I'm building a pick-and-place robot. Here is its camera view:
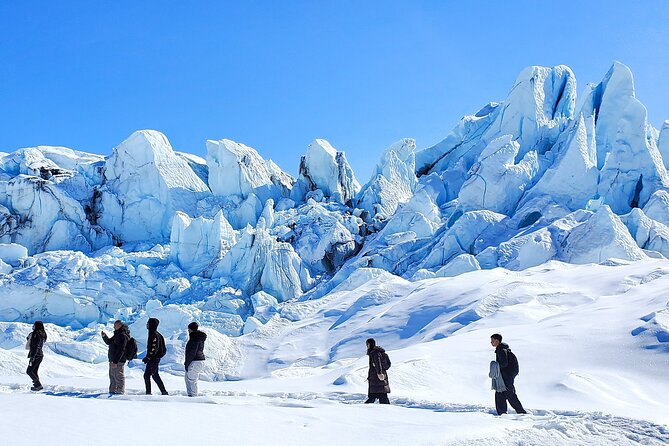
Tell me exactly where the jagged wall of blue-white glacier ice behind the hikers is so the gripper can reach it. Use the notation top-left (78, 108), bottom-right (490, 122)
top-left (0, 63), bottom-right (669, 336)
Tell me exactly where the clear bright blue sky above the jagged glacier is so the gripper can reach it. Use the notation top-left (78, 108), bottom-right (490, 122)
top-left (0, 0), bottom-right (669, 183)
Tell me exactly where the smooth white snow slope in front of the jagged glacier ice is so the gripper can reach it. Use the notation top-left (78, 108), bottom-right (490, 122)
top-left (0, 259), bottom-right (669, 445)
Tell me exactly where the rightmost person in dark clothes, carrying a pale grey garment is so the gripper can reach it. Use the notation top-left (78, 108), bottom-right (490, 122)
top-left (490, 333), bottom-right (527, 415)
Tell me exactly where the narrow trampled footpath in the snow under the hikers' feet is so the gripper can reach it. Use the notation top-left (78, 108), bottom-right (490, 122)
top-left (0, 384), bottom-right (669, 446)
